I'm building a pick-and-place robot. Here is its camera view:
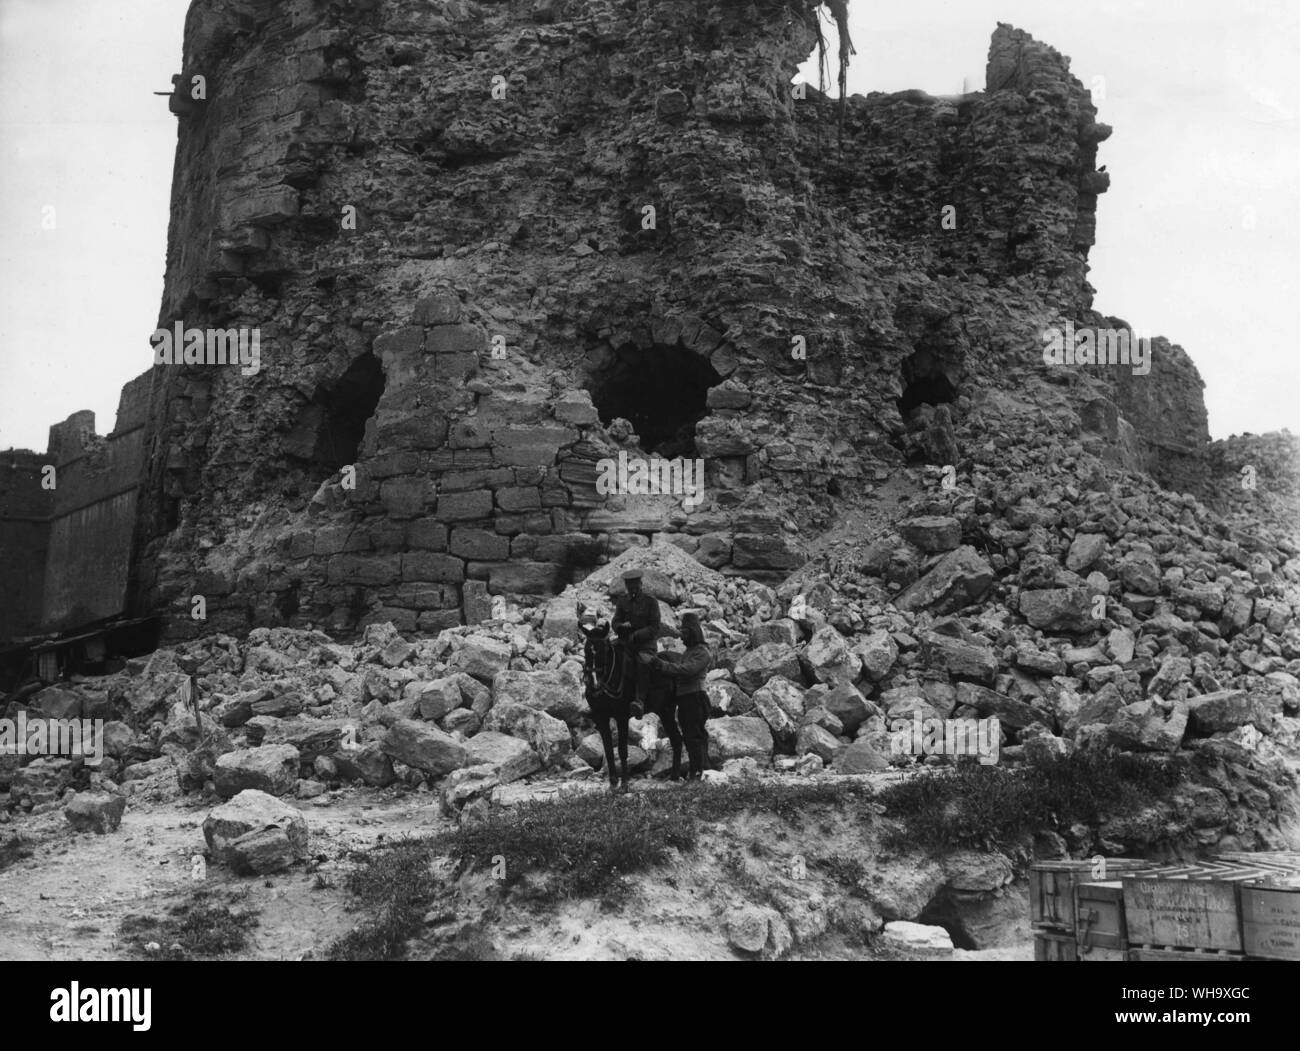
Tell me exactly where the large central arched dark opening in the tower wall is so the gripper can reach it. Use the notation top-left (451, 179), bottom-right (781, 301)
top-left (588, 345), bottom-right (723, 459)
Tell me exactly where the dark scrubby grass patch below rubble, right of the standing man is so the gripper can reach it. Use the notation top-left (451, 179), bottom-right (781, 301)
top-left (880, 752), bottom-right (1188, 852)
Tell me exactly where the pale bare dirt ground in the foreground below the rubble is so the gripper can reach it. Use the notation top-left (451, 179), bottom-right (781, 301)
top-left (0, 787), bottom-right (1034, 961)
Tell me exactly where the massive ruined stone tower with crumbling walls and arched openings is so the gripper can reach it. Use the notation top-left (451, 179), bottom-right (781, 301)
top-left (122, 0), bottom-right (1208, 633)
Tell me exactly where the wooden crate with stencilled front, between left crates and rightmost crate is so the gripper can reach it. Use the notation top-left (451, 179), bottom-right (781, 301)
top-left (1122, 862), bottom-right (1269, 952)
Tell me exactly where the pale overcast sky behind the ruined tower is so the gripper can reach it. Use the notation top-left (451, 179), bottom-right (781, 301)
top-left (0, 0), bottom-right (1300, 450)
